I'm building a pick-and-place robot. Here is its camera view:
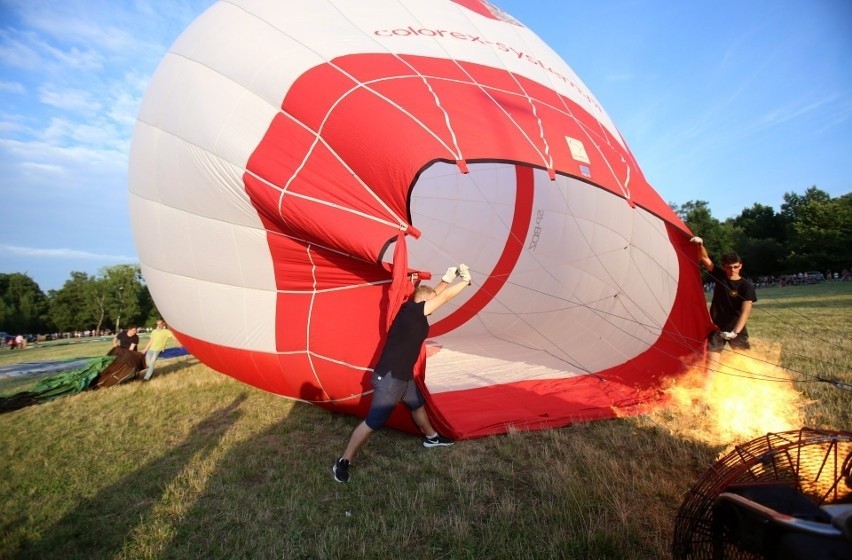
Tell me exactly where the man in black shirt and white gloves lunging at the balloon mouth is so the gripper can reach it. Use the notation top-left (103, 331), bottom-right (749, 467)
top-left (331, 264), bottom-right (471, 482)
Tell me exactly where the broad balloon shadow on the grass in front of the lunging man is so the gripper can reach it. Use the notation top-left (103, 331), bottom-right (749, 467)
top-left (148, 384), bottom-right (713, 559)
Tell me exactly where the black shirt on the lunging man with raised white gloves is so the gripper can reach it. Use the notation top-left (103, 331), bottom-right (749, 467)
top-left (376, 301), bottom-right (429, 381)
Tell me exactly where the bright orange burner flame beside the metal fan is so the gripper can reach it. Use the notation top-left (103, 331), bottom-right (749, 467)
top-left (649, 343), bottom-right (806, 445)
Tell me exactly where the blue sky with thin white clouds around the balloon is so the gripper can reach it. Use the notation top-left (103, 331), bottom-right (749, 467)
top-left (0, 0), bottom-right (852, 292)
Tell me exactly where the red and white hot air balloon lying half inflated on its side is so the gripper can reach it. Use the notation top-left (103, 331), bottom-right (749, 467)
top-left (129, 0), bottom-right (711, 438)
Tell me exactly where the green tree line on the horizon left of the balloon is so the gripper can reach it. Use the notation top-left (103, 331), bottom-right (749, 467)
top-left (0, 264), bottom-right (158, 340)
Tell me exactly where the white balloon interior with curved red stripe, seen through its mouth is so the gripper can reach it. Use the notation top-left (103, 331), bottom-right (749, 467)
top-left (408, 161), bottom-right (678, 381)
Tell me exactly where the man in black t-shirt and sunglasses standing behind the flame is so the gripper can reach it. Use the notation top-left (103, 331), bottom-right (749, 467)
top-left (690, 237), bottom-right (757, 363)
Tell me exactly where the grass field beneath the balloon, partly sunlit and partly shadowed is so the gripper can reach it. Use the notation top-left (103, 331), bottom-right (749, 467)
top-left (0, 283), bottom-right (852, 560)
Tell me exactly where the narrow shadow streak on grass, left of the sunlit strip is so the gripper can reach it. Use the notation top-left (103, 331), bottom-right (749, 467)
top-left (15, 393), bottom-right (247, 560)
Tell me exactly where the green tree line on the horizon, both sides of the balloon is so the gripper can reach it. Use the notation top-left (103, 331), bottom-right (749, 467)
top-left (0, 187), bottom-right (852, 333)
